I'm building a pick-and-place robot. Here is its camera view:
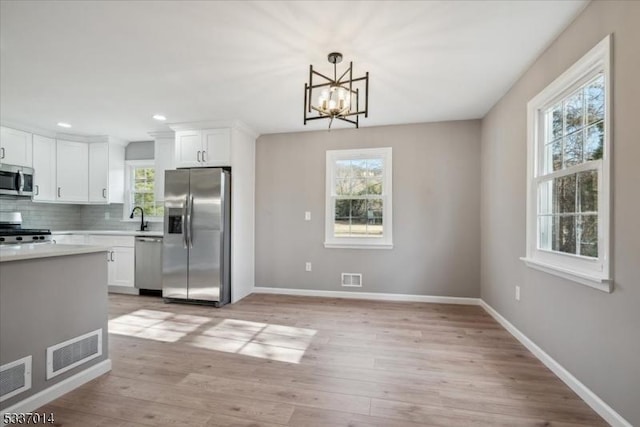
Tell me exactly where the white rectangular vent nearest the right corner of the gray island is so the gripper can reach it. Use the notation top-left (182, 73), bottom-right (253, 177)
top-left (47, 329), bottom-right (102, 379)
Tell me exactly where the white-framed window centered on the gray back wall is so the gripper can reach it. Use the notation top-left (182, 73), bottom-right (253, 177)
top-left (325, 148), bottom-right (393, 249)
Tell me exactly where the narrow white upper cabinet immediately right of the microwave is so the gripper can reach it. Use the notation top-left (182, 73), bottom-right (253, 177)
top-left (33, 135), bottom-right (56, 202)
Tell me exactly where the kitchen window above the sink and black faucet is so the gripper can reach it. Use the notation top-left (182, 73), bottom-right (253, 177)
top-left (124, 160), bottom-right (164, 221)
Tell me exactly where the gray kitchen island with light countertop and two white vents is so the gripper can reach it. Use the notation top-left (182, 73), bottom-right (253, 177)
top-left (0, 244), bottom-right (111, 413)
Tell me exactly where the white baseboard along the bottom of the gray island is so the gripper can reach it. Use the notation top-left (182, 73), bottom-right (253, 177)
top-left (0, 359), bottom-right (111, 426)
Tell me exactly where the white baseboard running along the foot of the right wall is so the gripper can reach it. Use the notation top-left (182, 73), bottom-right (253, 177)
top-left (480, 300), bottom-right (632, 427)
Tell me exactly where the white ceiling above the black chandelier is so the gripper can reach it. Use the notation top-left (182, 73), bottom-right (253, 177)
top-left (0, 0), bottom-right (587, 141)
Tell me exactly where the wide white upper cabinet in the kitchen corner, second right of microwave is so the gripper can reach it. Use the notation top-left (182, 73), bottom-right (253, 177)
top-left (56, 139), bottom-right (89, 203)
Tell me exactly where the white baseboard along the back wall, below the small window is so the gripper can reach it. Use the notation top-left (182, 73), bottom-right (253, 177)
top-left (253, 286), bottom-right (480, 305)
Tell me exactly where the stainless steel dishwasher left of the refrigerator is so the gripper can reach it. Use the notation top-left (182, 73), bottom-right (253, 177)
top-left (135, 236), bottom-right (162, 291)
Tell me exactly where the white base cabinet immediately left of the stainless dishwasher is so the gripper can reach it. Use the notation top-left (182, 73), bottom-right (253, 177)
top-left (88, 235), bottom-right (138, 294)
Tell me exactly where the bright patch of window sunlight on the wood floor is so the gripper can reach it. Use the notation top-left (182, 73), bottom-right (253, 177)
top-left (109, 310), bottom-right (317, 363)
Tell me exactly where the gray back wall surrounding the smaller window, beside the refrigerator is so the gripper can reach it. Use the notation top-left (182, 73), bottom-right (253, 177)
top-left (255, 120), bottom-right (480, 297)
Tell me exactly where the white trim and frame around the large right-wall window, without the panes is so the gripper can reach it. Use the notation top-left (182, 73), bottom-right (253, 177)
top-left (520, 35), bottom-right (613, 292)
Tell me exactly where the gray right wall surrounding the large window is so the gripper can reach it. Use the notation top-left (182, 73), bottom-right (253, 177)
top-left (481, 1), bottom-right (640, 425)
